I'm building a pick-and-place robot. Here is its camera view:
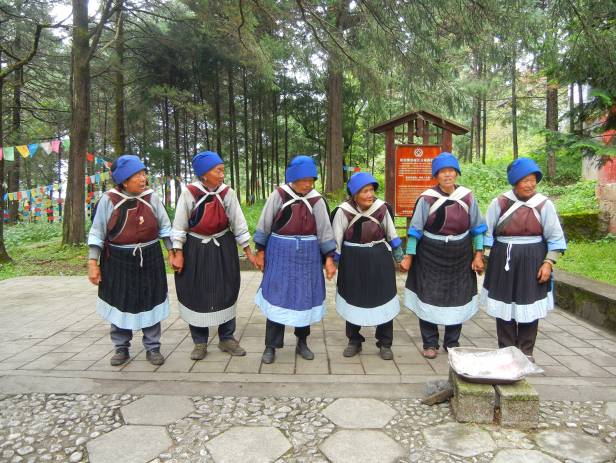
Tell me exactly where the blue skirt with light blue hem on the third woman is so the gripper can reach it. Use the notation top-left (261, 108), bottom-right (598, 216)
top-left (255, 233), bottom-right (325, 326)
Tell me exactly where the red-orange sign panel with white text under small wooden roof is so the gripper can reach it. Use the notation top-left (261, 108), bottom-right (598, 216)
top-left (395, 145), bottom-right (441, 217)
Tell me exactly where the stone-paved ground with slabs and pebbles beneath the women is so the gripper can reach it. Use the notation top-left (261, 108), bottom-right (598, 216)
top-left (0, 272), bottom-right (616, 463)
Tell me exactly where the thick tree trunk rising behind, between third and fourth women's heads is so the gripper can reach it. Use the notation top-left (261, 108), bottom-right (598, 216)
top-left (325, 59), bottom-right (344, 193)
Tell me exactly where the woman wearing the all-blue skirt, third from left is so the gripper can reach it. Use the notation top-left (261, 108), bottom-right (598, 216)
top-left (254, 156), bottom-right (336, 363)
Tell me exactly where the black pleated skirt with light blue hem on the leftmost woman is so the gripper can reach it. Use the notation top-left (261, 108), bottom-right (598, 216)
top-left (97, 241), bottom-right (169, 329)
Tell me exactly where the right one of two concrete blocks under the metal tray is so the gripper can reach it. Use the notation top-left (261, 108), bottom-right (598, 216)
top-left (494, 379), bottom-right (539, 428)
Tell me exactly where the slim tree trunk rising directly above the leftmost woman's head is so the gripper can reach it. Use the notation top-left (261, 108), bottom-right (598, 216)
top-left (113, 0), bottom-right (126, 156)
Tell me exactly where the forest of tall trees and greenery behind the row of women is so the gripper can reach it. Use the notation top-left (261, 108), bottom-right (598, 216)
top-left (0, 0), bottom-right (616, 283)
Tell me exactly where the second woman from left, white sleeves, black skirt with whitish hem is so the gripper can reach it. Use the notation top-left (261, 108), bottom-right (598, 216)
top-left (171, 151), bottom-right (254, 360)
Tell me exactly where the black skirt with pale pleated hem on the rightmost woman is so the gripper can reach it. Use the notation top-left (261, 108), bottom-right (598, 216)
top-left (481, 240), bottom-right (554, 323)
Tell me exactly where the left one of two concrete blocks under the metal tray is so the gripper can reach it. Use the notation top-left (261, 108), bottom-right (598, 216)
top-left (449, 369), bottom-right (496, 423)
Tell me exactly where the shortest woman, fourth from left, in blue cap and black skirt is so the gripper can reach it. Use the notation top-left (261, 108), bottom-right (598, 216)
top-left (332, 172), bottom-right (404, 360)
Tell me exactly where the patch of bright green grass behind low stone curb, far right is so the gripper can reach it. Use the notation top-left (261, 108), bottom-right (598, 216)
top-left (557, 235), bottom-right (616, 285)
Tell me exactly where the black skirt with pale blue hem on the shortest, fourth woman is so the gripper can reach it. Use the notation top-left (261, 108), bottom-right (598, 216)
top-left (336, 243), bottom-right (400, 326)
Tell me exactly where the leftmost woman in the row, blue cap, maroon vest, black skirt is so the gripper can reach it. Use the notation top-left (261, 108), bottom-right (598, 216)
top-left (88, 155), bottom-right (171, 366)
